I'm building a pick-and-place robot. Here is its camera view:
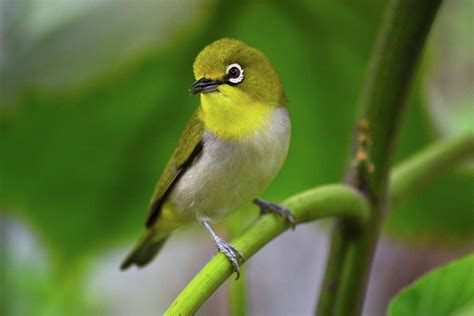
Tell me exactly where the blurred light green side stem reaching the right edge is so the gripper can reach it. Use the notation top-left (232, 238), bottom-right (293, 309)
top-left (390, 134), bottom-right (474, 208)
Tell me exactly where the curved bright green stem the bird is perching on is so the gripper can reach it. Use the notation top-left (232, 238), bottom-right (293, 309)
top-left (165, 184), bottom-right (368, 315)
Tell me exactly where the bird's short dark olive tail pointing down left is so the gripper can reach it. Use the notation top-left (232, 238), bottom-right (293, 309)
top-left (120, 229), bottom-right (169, 270)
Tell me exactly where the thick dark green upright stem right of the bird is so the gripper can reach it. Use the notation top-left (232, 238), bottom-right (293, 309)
top-left (316, 0), bottom-right (441, 316)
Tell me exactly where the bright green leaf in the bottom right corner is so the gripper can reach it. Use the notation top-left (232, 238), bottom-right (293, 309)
top-left (388, 254), bottom-right (474, 316)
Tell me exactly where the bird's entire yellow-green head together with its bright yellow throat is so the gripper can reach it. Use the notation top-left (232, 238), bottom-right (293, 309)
top-left (189, 38), bottom-right (287, 139)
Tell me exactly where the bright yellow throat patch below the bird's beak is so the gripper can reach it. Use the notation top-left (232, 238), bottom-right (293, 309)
top-left (200, 86), bottom-right (275, 140)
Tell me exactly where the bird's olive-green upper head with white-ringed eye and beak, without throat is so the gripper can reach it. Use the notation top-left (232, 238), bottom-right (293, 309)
top-left (189, 38), bottom-right (287, 106)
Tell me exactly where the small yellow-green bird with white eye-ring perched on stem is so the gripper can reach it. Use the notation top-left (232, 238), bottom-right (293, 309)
top-left (120, 38), bottom-right (295, 278)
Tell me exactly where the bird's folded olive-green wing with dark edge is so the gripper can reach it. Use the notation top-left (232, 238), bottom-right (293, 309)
top-left (146, 110), bottom-right (204, 228)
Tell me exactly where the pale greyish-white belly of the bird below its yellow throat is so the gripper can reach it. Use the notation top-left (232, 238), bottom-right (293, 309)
top-left (170, 108), bottom-right (291, 221)
